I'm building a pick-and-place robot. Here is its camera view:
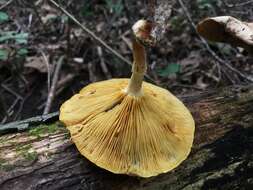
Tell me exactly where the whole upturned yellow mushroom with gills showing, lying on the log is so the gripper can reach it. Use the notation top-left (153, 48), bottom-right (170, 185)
top-left (60, 20), bottom-right (195, 177)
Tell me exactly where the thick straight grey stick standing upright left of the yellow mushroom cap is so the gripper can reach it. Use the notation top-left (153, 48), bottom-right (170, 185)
top-left (43, 56), bottom-right (64, 114)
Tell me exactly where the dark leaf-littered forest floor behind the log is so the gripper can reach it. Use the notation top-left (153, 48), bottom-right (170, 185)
top-left (0, 0), bottom-right (253, 123)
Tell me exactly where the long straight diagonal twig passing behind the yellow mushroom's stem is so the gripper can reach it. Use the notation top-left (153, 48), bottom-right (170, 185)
top-left (49, 0), bottom-right (156, 83)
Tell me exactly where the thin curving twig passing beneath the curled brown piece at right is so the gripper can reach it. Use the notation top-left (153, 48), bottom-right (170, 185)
top-left (178, 0), bottom-right (253, 82)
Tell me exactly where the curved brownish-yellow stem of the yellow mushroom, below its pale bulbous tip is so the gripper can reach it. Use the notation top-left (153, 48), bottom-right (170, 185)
top-left (127, 39), bottom-right (147, 96)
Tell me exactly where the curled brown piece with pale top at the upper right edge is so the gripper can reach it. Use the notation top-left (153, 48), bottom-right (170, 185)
top-left (197, 16), bottom-right (253, 53)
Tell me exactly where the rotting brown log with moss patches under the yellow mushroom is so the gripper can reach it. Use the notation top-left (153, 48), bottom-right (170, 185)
top-left (0, 86), bottom-right (253, 190)
